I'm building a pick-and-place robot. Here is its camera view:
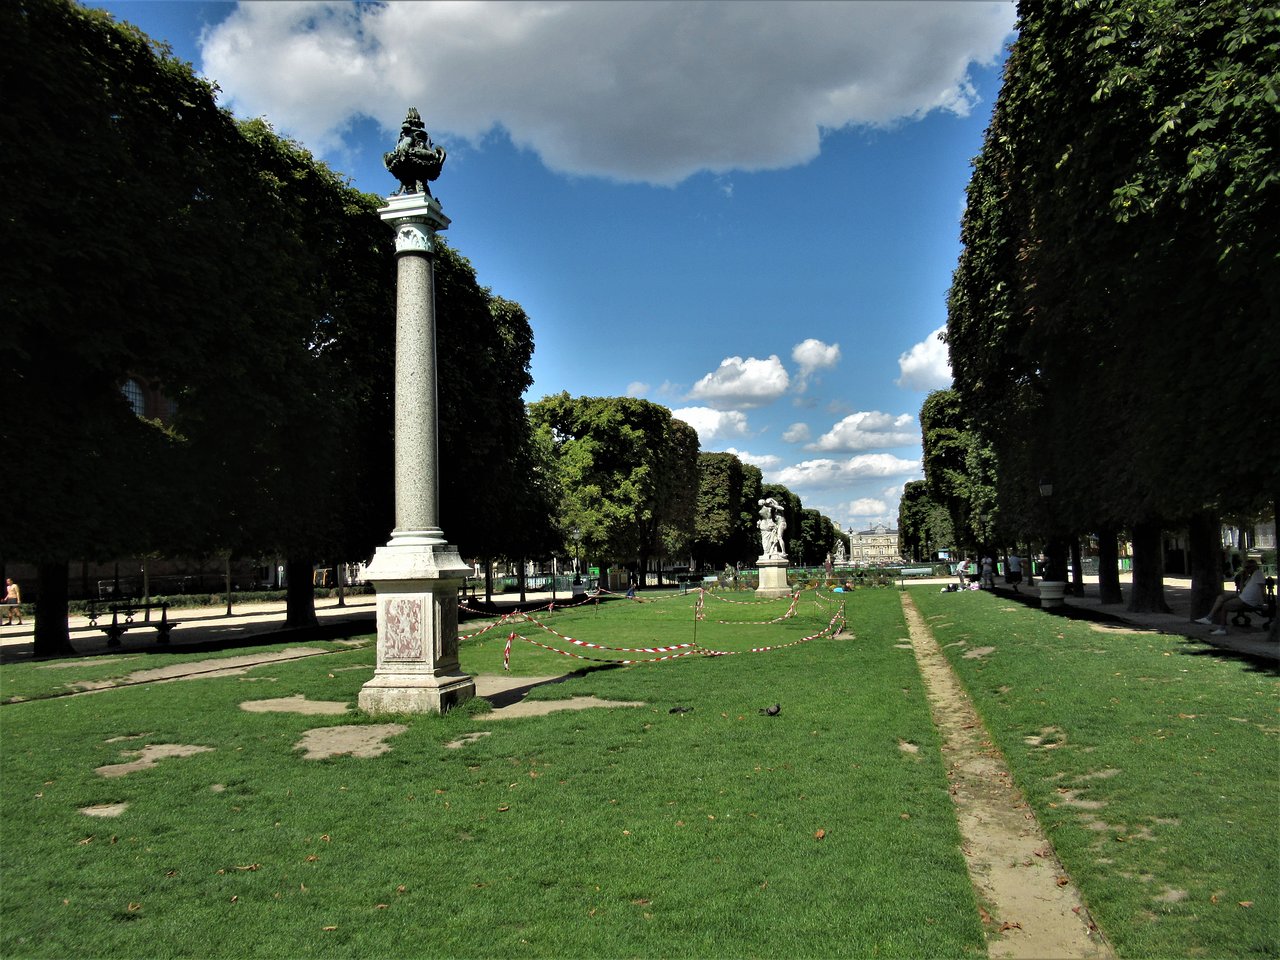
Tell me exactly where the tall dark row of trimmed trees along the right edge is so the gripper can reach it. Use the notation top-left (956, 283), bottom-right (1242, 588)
top-left (947, 0), bottom-right (1280, 612)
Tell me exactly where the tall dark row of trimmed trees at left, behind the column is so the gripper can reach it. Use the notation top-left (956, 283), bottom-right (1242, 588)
top-left (0, 0), bottom-right (548, 654)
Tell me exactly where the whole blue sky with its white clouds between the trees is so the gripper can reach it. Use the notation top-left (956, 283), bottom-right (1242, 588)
top-left (92, 0), bottom-right (1015, 542)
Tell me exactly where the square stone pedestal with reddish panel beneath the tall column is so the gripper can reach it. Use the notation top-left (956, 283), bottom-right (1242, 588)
top-left (358, 541), bottom-right (476, 713)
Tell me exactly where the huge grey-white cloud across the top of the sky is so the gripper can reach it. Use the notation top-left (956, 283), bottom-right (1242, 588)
top-left (201, 0), bottom-right (1016, 184)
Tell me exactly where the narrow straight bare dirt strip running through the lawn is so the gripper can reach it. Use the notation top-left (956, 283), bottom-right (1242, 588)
top-left (902, 591), bottom-right (1114, 960)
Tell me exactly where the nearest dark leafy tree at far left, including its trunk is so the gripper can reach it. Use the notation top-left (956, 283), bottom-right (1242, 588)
top-left (0, 0), bottom-right (266, 655)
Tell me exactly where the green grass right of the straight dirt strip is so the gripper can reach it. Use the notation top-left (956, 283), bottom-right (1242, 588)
top-left (911, 588), bottom-right (1280, 957)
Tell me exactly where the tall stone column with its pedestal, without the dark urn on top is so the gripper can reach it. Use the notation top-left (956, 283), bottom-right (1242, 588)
top-left (360, 193), bottom-right (475, 713)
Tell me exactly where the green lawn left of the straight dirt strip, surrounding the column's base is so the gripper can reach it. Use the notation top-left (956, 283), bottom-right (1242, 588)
top-left (0, 590), bottom-right (984, 957)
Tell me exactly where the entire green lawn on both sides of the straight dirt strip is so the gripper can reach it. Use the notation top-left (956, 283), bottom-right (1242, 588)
top-left (0, 588), bottom-right (1280, 957)
